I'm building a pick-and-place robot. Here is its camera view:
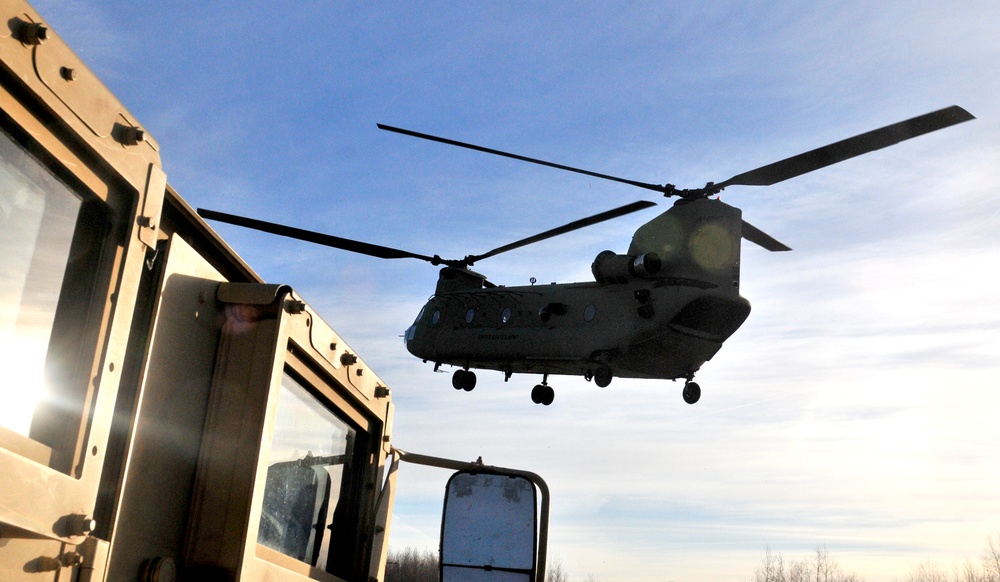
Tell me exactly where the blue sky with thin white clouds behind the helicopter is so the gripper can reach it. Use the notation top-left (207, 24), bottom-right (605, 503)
top-left (36, 0), bottom-right (1000, 581)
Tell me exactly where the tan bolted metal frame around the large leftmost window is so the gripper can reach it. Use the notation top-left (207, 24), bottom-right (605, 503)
top-left (0, 28), bottom-right (166, 544)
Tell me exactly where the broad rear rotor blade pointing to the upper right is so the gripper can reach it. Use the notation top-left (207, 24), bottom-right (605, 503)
top-left (715, 105), bottom-right (975, 189)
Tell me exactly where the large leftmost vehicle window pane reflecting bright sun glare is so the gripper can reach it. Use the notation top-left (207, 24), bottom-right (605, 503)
top-left (0, 125), bottom-right (110, 464)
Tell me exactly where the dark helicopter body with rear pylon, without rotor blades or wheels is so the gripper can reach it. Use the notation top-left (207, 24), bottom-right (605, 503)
top-left (405, 199), bottom-right (750, 388)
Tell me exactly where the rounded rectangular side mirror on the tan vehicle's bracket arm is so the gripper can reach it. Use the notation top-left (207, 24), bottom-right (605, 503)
top-left (441, 471), bottom-right (538, 582)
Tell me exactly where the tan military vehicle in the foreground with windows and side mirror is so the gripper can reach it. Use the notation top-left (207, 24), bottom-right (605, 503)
top-left (0, 0), bottom-right (548, 582)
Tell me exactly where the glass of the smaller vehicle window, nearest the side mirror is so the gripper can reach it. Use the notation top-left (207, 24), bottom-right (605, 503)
top-left (257, 372), bottom-right (365, 574)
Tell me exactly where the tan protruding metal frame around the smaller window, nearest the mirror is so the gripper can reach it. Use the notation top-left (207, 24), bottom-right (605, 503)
top-left (185, 283), bottom-right (392, 582)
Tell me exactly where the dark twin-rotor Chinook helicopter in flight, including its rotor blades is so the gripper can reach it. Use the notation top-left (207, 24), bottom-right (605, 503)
top-left (198, 106), bottom-right (974, 405)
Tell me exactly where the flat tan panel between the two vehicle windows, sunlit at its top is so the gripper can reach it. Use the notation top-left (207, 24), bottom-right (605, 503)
top-left (108, 235), bottom-right (225, 580)
